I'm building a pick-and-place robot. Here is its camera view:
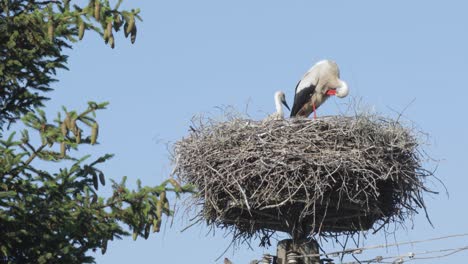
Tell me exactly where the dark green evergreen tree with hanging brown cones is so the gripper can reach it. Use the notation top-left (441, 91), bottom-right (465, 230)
top-left (0, 0), bottom-right (191, 263)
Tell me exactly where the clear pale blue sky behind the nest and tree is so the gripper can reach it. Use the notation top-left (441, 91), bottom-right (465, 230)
top-left (48, 0), bottom-right (468, 264)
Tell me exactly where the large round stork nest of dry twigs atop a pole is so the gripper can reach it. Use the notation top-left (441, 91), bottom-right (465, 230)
top-left (173, 114), bottom-right (432, 245)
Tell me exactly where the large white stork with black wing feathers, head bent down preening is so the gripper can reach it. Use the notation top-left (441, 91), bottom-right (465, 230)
top-left (291, 60), bottom-right (349, 118)
